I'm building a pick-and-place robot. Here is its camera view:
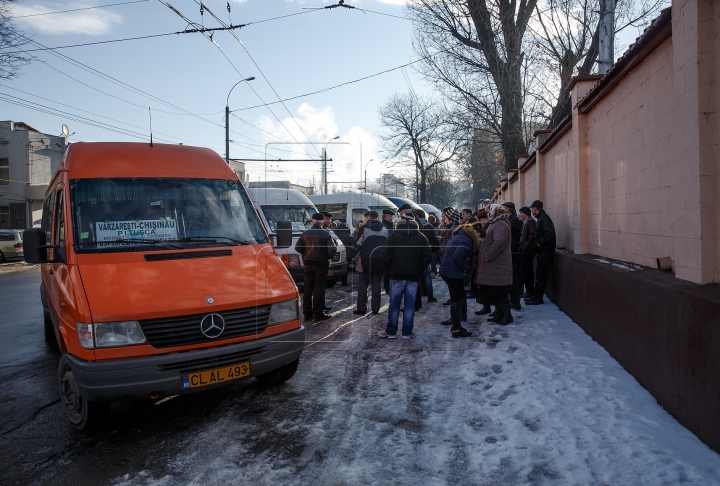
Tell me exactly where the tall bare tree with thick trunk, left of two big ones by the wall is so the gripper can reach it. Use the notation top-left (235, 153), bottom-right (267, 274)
top-left (408, 0), bottom-right (538, 169)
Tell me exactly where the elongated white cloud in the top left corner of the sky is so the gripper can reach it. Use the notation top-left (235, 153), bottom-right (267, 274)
top-left (12, 4), bottom-right (123, 35)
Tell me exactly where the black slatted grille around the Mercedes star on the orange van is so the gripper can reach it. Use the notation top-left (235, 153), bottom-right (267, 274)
top-left (140, 305), bottom-right (270, 348)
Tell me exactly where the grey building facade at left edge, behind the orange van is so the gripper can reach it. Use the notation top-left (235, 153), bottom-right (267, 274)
top-left (0, 121), bottom-right (67, 229)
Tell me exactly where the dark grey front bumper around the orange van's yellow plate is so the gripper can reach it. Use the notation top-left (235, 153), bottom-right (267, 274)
top-left (67, 327), bottom-right (305, 401)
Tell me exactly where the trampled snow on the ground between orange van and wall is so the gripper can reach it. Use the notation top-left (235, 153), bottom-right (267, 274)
top-left (116, 280), bottom-right (720, 485)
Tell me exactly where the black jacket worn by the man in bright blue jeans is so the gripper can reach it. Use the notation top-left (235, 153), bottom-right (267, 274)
top-left (382, 219), bottom-right (431, 282)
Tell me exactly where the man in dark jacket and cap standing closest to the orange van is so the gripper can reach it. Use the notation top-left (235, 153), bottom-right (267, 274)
top-left (295, 213), bottom-right (337, 320)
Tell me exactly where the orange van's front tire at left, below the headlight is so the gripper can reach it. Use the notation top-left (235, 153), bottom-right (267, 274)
top-left (58, 355), bottom-right (110, 430)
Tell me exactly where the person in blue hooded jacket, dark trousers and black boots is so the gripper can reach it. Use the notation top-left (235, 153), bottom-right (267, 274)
top-left (440, 222), bottom-right (480, 338)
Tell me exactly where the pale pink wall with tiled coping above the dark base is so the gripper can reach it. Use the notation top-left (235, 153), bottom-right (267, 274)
top-left (495, 0), bottom-right (720, 284)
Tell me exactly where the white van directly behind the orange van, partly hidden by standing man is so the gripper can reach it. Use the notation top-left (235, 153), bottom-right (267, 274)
top-left (247, 188), bottom-right (348, 287)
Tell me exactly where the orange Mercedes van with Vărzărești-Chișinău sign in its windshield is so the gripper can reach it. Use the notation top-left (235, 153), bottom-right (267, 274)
top-left (24, 142), bottom-right (305, 429)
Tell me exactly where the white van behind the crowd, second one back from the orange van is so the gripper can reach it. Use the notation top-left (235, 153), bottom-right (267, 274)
top-left (310, 192), bottom-right (397, 228)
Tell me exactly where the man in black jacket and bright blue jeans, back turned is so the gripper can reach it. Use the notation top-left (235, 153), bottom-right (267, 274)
top-left (378, 214), bottom-right (432, 339)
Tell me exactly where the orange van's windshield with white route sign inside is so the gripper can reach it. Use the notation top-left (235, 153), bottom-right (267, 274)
top-left (70, 178), bottom-right (267, 251)
